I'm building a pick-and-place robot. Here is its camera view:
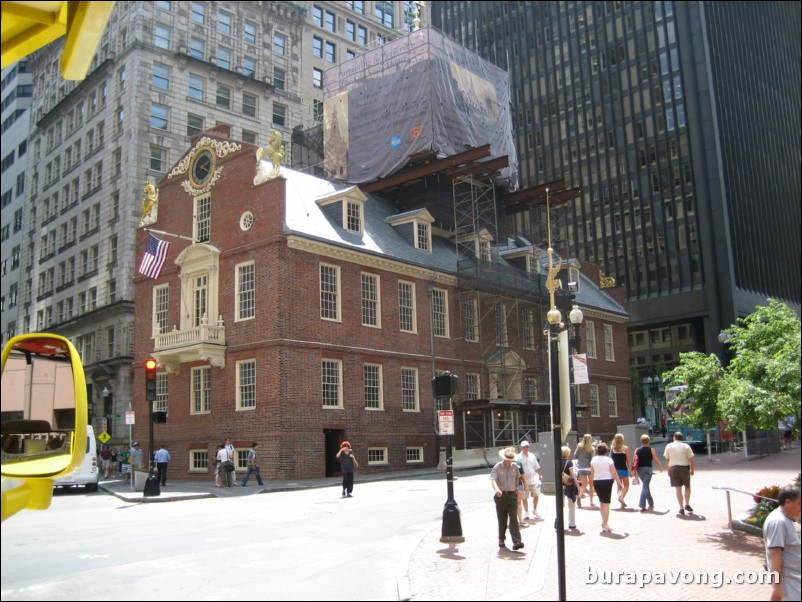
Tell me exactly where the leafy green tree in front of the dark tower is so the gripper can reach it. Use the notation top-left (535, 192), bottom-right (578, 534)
top-left (665, 299), bottom-right (802, 430)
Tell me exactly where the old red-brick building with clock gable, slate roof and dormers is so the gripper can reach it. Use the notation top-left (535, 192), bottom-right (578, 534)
top-left (134, 126), bottom-right (632, 479)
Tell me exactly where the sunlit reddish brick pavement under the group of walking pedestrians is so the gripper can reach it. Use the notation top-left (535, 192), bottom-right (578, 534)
top-left (400, 442), bottom-right (802, 600)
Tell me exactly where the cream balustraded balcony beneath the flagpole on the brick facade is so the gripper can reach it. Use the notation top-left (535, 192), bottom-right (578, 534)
top-left (151, 316), bottom-right (226, 374)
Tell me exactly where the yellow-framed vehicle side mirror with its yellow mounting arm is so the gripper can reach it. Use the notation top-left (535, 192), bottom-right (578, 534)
top-left (0, 333), bottom-right (87, 520)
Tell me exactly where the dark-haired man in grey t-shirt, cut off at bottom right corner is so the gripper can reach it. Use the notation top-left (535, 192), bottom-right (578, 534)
top-left (763, 485), bottom-right (802, 600)
